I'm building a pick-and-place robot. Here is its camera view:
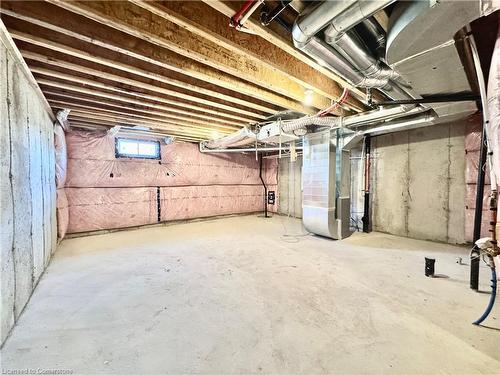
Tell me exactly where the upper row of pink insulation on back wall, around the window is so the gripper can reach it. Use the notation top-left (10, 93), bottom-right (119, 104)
top-left (66, 132), bottom-right (277, 191)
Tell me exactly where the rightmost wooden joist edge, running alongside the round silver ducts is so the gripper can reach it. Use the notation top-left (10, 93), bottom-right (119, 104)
top-left (202, 0), bottom-right (366, 101)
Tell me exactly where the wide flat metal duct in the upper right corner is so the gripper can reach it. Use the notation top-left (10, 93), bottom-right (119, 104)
top-left (386, 0), bottom-right (499, 117)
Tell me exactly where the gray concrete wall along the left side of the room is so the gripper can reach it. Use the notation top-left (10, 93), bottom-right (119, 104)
top-left (0, 27), bottom-right (57, 344)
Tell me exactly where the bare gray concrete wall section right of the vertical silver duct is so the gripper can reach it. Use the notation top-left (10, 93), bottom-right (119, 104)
top-left (372, 120), bottom-right (466, 243)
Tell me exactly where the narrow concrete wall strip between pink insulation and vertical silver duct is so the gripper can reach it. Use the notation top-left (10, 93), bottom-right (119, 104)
top-left (278, 156), bottom-right (302, 218)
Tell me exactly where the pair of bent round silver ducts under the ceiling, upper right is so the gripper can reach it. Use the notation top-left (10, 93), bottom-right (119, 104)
top-left (292, 0), bottom-right (417, 100)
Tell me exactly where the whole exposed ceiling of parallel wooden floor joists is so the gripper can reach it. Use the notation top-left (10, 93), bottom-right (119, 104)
top-left (0, 0), bottom-right (376, 140)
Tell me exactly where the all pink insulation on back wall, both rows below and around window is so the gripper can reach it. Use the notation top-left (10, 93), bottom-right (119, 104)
top-left (66, 131), bottom-right (277, 233)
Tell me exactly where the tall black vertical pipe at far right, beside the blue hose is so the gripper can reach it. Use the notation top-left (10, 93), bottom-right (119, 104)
top-left (470, 125), bottom-right (488, 290)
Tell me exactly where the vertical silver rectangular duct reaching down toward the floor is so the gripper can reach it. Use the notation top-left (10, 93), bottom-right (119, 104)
top-left (302, 130), bottom-right (351, 240)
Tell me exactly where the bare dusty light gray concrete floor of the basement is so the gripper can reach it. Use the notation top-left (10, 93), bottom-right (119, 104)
top-left (2, 216), bottom-right (500, 375)
